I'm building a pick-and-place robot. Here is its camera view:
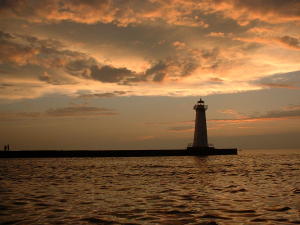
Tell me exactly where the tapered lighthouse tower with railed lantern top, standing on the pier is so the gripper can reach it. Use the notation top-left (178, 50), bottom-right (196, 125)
top-left (192, 98), bottom-right (208, 148)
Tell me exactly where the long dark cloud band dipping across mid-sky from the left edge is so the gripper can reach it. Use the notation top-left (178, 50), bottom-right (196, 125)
top-left (0, 29), bottom-right (218, 85)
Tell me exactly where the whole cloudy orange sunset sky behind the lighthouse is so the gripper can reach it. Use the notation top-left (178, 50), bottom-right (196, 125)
top-left (0, 0), bottom-right (300, 150)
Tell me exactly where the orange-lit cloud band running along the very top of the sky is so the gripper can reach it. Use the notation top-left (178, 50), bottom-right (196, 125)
top-left (0, 0), bottom-right (300, 28)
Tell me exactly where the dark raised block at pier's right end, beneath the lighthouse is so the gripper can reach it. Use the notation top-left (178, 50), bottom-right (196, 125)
top-left (187, 147), bottom-right (237, 155)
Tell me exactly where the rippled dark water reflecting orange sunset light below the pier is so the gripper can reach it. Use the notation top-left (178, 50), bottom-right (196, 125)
top-left (0, 150), bottom-right (300, 225)
